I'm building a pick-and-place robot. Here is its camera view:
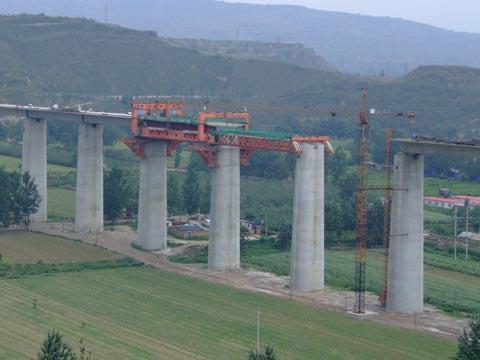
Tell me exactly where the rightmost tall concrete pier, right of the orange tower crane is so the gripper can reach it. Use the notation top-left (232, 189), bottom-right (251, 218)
top-left (387, 153), bottom-right (423, 313)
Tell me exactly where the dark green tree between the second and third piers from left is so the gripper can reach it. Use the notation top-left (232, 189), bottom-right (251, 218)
top-left (103, 167), bottom-right (130, 220)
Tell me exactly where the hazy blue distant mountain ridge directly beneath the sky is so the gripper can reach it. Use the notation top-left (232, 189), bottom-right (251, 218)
top-left (0, 0), bottom-right (480, 76)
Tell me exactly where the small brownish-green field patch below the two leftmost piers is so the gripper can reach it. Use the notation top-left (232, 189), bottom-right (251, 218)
top-left (0, 232), bottom-right (122, 264)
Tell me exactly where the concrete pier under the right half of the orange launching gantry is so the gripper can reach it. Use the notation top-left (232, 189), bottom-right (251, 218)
top-left (208, 146), bottom-right (240, 270)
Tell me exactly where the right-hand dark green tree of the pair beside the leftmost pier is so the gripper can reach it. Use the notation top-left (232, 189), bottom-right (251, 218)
top-left (12, 172), bottom-right (42, 226)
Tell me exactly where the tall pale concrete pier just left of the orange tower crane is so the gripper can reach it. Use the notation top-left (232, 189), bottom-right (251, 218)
top-left (290, 144), bottom-right (325, 291)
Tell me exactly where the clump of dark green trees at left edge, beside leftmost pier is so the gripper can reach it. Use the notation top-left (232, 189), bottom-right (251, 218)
top-left (0, 168), bottom-right (41, 227)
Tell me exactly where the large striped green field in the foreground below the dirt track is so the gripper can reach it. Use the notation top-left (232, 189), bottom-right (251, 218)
top-left (0, 268), bottom-right (454, 359)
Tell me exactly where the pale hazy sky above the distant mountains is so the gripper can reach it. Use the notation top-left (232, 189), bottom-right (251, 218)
top-left (226, 0), bottom-right (480, 33)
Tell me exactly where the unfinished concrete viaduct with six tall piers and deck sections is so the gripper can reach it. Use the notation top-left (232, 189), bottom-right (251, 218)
top-left (0, 105), bottom-right (470, 313)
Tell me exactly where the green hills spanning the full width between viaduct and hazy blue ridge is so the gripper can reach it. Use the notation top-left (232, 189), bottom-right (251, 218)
top-left (0, 15), bottom-right (480, 137)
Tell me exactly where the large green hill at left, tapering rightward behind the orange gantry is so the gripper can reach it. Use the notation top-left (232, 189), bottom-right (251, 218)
top-left (0, 15), bottom-right (343, 102)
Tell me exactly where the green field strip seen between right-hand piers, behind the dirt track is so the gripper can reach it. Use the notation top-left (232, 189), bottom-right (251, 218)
top-left (171, 242), bottom-right (480, 312)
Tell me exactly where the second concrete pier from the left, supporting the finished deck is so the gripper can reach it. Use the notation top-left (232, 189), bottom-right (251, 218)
top-left (75, 124), bottom-right (103, 233)
